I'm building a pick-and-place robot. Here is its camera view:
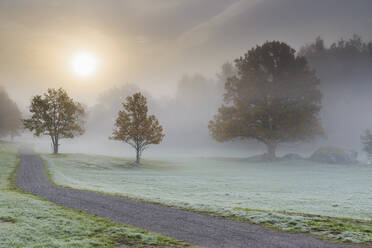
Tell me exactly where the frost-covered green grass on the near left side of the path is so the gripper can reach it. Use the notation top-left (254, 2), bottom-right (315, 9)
top-left (0, 141), bottom-right (183, 248)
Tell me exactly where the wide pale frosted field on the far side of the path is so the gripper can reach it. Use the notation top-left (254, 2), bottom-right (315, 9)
top-left (43, 154), bottom-right (372, 242)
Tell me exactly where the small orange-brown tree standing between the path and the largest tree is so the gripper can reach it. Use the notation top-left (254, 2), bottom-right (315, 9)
top-left (110, 92), bottom-right (164, 164)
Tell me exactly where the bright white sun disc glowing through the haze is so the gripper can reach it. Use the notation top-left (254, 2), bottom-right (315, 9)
top-left (71, 52), bottom-right (98, 77)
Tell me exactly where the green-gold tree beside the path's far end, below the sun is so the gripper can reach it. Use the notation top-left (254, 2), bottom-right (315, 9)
top-left (23, 88), bottom-right (85, 154)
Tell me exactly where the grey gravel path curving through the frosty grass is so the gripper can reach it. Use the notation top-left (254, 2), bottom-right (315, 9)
top-left (16, 148), bottom-right (356, 248)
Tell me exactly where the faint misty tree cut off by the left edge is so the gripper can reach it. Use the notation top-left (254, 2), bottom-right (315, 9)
top-left (0, 87), bottom-right (22, 139)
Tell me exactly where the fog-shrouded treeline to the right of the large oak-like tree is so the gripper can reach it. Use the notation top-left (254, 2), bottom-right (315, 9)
top-left (299, 35), bottom-right (372, 147)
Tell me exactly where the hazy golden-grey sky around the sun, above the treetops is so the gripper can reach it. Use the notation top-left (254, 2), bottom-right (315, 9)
top-left (0, 0), bottom-right (372, 104)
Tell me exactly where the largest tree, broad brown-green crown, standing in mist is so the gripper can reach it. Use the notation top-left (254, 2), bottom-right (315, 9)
top-left (209, 41), bottom-right (323, 160)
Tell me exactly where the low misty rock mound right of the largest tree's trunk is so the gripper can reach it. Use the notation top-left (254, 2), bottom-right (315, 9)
top-left (310, 147), bottom-right (358, 164)
